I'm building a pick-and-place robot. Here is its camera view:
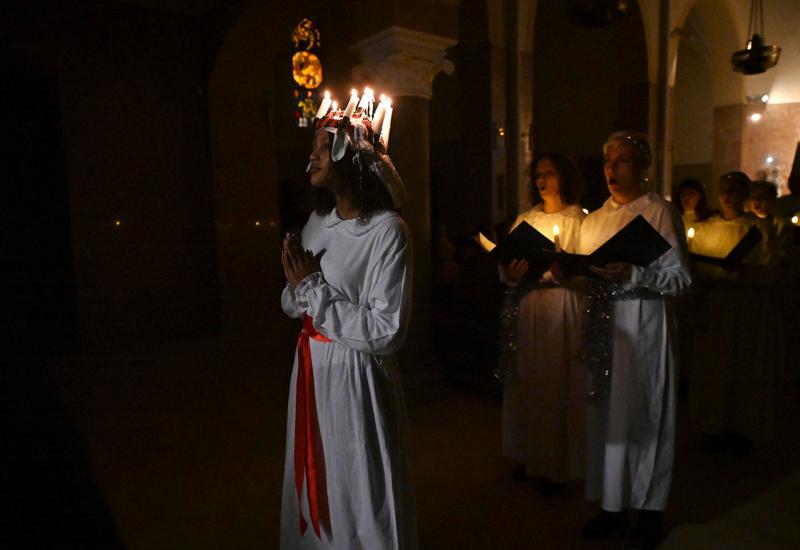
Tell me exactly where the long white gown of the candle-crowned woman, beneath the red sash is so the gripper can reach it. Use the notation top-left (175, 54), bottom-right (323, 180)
top-left (281, 209), bottom-right (417, 550)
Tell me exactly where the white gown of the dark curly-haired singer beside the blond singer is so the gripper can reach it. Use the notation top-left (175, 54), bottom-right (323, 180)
top-left (503, 204), bottom-right (587, 481)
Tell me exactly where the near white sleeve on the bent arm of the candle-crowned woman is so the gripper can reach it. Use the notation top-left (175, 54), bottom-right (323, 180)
top-left (295, 222), bottom-right (411, 355)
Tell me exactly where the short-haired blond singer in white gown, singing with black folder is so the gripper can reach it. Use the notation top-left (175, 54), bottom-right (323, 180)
top-left (577, 131), bottom-right (691, 548)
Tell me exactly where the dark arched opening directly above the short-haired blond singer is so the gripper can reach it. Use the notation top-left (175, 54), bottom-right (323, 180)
top-left (531, 2), bottom-right (651, 211)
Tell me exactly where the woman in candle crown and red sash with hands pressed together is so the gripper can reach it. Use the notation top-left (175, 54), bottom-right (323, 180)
top-left (281, 88), bottom-right (417, 550)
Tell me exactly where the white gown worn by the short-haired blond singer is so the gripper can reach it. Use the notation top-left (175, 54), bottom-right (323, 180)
top-left (578, 192), bottom-right (691, 512)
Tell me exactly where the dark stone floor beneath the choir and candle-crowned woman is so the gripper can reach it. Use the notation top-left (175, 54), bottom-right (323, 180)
top-left (6, 323), bottom-right (800, 550)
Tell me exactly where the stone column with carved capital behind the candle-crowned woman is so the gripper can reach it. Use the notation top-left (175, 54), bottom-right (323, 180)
top-left (350, 27), bottom-right (456, 383)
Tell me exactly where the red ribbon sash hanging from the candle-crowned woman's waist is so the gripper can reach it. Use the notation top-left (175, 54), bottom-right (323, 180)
top-left (294, 315), bottom-right (331, 538)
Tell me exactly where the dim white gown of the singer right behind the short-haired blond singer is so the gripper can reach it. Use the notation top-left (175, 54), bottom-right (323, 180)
top-left (689, 214), bottom-right (783, 441)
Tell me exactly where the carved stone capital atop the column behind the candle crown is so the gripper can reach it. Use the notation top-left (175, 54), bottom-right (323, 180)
top-left (350, 26), bottom-right (457, 99)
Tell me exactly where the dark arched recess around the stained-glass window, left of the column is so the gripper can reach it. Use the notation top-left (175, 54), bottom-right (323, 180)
top-left (208, 0), bottom-right (356, 330)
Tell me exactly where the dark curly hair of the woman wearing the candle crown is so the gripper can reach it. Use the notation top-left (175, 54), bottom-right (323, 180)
top-left (311, 139), bottom-right (395, 224)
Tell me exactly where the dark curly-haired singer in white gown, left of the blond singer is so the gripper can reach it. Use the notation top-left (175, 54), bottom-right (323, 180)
top-left (499, 151), bottom-right (586, 495)
